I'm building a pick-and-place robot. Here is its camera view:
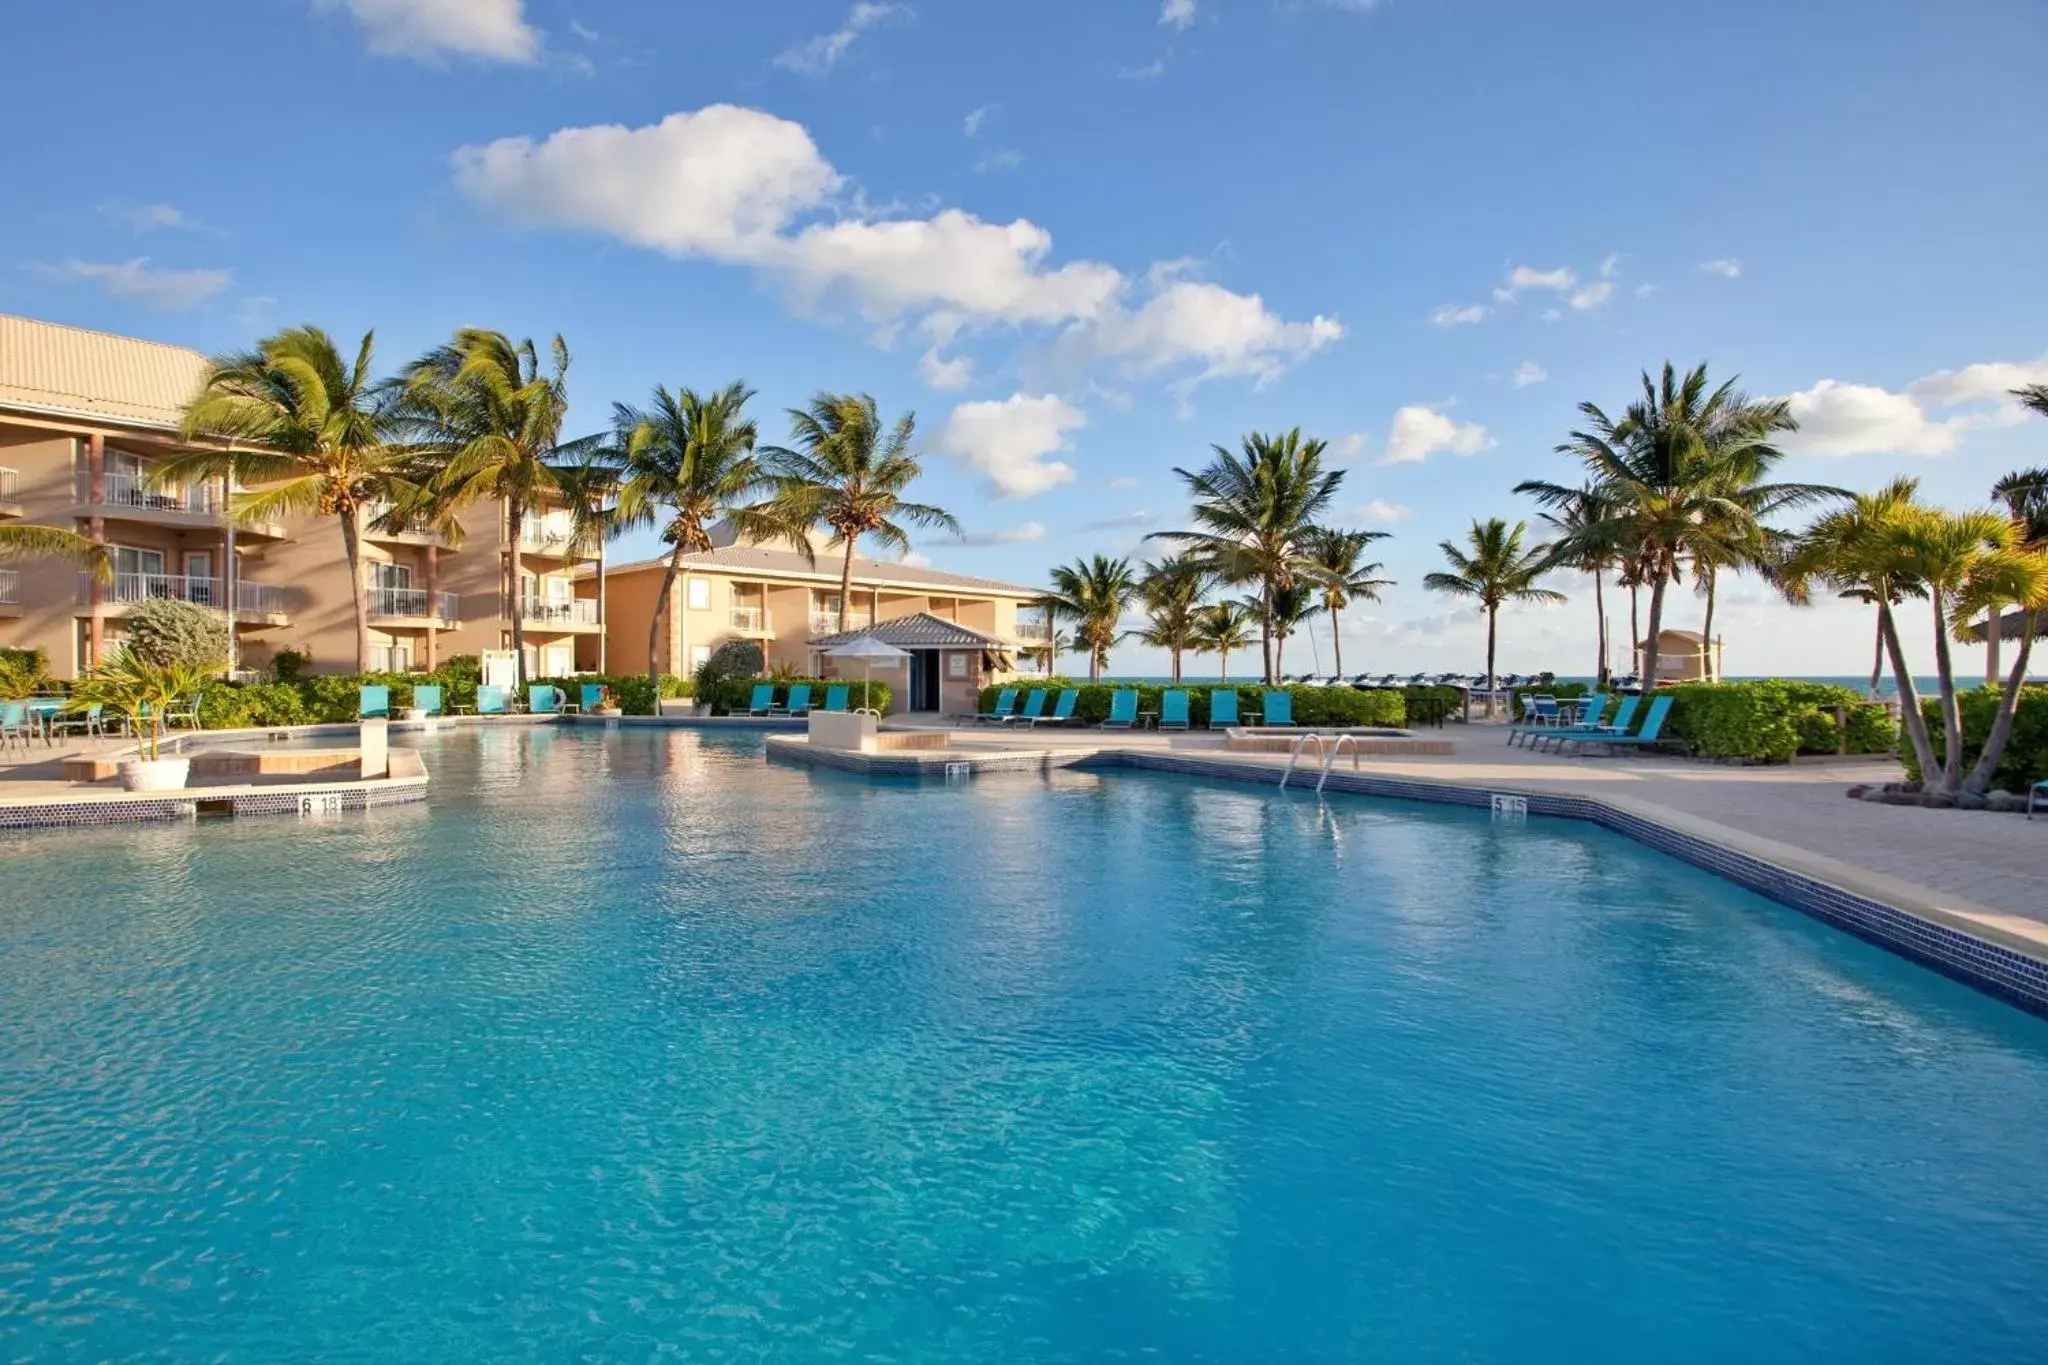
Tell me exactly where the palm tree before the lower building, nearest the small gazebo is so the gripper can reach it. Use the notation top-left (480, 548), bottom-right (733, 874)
top-left (762, 393), bottom-right (961, 630)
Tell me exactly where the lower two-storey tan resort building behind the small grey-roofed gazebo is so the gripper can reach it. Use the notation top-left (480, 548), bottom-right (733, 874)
top-left (578, 528), bottom-right (1049, 712)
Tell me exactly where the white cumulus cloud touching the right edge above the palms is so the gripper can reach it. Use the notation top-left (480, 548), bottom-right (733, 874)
top-left (1786, 356), bottom-right (2048, 456)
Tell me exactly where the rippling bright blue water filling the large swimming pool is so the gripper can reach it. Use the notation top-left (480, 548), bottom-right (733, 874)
top-left (0, 729), bottom-right (2048, 1363)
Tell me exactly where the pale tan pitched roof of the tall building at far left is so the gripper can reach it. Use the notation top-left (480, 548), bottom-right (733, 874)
top-left (0, 313), bottom-right (207, 430)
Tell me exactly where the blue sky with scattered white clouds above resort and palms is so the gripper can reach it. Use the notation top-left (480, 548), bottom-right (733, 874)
top-left (0, 0), bottom-right (2048, 675)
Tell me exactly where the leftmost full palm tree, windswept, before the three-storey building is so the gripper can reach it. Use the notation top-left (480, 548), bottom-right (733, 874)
top-left (150, 325), bottom-right (403, 673)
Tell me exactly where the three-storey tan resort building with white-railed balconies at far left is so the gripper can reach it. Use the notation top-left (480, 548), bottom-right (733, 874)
top-left (0, 315), bottom-right (602, 677)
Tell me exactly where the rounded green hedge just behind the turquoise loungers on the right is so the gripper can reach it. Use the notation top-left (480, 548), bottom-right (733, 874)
top-left (1655, 677), bottom-right (1898, 763)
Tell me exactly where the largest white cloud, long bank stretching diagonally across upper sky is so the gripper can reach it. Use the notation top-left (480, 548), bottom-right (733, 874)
top-left (453, 104), bottom-right (1343, 383)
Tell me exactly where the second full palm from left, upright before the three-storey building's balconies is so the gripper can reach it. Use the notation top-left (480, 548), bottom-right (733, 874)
top-left (391, 327), bottom-right (602, 690)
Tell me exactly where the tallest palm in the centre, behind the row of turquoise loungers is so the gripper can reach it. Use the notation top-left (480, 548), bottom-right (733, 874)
top-left (1147, 428), bottom-right (1343, 684)
